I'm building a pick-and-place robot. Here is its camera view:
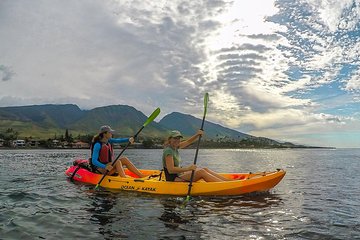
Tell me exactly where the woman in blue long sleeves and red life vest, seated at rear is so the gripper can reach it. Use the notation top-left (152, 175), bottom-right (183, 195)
top-left (90, 125), bottom-right (145, 177)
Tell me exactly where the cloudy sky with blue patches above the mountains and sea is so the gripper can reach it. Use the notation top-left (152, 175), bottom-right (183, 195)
top-left (0, 0), bottom-right (360, 148)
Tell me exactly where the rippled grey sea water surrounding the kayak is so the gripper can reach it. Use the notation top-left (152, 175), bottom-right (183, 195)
top-left (0, 149), bottom-right (360, 240)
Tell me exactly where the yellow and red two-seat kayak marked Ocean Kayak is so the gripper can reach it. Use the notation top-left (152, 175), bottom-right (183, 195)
top-left (65, 160), bottom-right (286, 196)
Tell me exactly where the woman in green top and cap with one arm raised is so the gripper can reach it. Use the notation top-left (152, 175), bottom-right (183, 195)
top-left (162, 130), bottom-right (231, 182)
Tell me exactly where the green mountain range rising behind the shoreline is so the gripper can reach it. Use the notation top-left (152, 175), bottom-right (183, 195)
top-left (0, 104), bottom-right (304, 145)
